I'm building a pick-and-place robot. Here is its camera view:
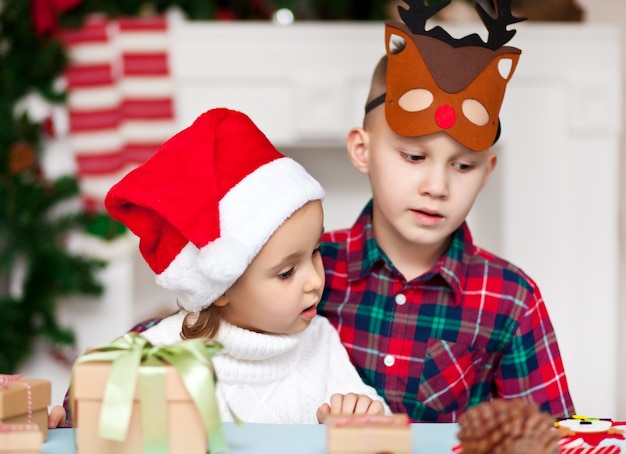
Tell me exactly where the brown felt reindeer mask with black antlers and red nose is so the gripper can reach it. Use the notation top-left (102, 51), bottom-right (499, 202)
top-left (366, 0), bottom-right (523, 151)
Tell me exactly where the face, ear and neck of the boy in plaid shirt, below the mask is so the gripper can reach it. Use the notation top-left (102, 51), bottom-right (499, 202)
top-left (348, 109), bottom-right (496, 254)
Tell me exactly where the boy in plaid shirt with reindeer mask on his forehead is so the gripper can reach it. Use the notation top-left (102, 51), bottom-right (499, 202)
top-left (320, 0), bottom-right (574, 422)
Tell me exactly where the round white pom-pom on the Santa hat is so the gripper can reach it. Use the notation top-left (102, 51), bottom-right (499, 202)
top-left (198, 238), bottom-right (252, 286)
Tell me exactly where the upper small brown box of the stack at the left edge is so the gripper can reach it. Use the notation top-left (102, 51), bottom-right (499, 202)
top-left (0, 375), bottom-right (52, 440)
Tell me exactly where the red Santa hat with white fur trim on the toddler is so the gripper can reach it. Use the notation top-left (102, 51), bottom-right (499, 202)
top-left (105, 108), bottom-right (324, 312)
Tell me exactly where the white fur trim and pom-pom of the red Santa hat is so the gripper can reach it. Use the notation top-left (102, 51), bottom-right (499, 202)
top-left (156, 157), bottom-right (324, 312)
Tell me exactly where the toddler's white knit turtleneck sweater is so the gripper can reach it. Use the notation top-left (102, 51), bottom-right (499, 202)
top-left (142, 312), bottom-right (390, 424)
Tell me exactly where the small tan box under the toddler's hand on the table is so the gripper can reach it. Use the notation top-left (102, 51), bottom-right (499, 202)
top-left (324, 414), bottom-right (413, 454)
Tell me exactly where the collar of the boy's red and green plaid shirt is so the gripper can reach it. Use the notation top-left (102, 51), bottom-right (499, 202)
top-left (347, 200), bottom-right (474, 305)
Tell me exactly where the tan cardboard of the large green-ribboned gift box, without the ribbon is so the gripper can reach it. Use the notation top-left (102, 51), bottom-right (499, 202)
top-left (72, 362), bottom-right (219, 454)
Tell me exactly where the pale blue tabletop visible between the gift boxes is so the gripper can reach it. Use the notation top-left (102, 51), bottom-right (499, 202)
top-left (41, 423), bottom-right (458, 454)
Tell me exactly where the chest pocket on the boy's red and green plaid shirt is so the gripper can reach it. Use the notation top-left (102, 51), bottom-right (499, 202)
top-left (417, 339), bottom-right (484, 413)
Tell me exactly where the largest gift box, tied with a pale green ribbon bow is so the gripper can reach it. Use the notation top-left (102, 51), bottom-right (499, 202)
top-left (70, 333), bottom-right (226, 454)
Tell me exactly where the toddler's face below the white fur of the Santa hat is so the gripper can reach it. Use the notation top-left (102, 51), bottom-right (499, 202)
top-left (214, 201), bottom-right (325, 334)
